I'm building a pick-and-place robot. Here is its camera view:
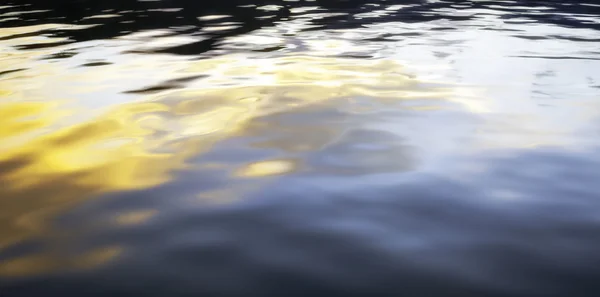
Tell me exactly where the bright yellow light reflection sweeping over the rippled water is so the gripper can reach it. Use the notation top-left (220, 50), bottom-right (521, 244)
top-left (0, 50), bottom-right (464, 246)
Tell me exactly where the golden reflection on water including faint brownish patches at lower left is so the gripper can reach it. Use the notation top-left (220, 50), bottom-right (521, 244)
top-left (0, 25), bottom-right (464, 276)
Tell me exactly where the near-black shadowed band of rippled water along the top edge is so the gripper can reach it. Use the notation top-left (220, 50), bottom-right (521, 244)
top-left (0, 0), bottom-right (600, 57)
